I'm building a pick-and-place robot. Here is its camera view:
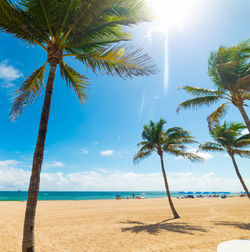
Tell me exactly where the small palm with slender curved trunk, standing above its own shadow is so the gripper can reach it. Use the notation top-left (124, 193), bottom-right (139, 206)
top-left (134, 119), bottom-right (201, 218)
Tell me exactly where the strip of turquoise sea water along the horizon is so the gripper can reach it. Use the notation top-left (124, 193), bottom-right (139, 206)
top-left (0, 191), bottom-right (235, 201)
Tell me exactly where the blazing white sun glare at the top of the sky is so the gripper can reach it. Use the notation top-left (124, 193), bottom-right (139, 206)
top-left (148, 0), bottom-right (193, 30)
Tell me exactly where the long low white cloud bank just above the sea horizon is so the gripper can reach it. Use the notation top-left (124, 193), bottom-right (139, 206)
top-left (0, 160), bottom-right (250, 192)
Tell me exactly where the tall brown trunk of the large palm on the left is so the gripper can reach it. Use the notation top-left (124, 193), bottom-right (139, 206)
top-left (22, 62), bottom-right (57, 252)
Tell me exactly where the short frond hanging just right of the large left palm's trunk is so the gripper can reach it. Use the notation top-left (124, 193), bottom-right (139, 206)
top-left (60, 61), bottom-right (88, 104)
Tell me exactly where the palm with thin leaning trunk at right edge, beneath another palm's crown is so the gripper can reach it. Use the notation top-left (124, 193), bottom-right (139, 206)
top-left (199, 122), bottom-right (250, 199)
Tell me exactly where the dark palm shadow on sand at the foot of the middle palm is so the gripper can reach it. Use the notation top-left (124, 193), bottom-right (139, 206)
top-left (120, 218), bottom-right (207, 235)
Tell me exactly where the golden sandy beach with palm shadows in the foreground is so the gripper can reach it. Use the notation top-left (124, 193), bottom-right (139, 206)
top-left (0, 197), bottom-right (250, 252)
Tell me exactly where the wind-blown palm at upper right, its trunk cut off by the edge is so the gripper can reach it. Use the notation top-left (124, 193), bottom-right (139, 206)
top-left (177, 40), bottom-right (250, 132)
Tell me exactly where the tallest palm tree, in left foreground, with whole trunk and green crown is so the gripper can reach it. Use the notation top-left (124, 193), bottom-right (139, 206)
top-left (0, 0), bottom-right (155, 252)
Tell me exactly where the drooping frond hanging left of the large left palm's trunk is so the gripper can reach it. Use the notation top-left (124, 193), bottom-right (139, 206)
top-left (10, 62), bottom-right (47, 120)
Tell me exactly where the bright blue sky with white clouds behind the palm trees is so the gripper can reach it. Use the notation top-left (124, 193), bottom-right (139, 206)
top-left (0, 0), bottom-right (250, 191)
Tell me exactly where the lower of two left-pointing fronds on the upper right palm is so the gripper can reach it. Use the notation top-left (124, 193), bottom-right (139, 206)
top-left (176, 96), bottom-right (220, 112)
